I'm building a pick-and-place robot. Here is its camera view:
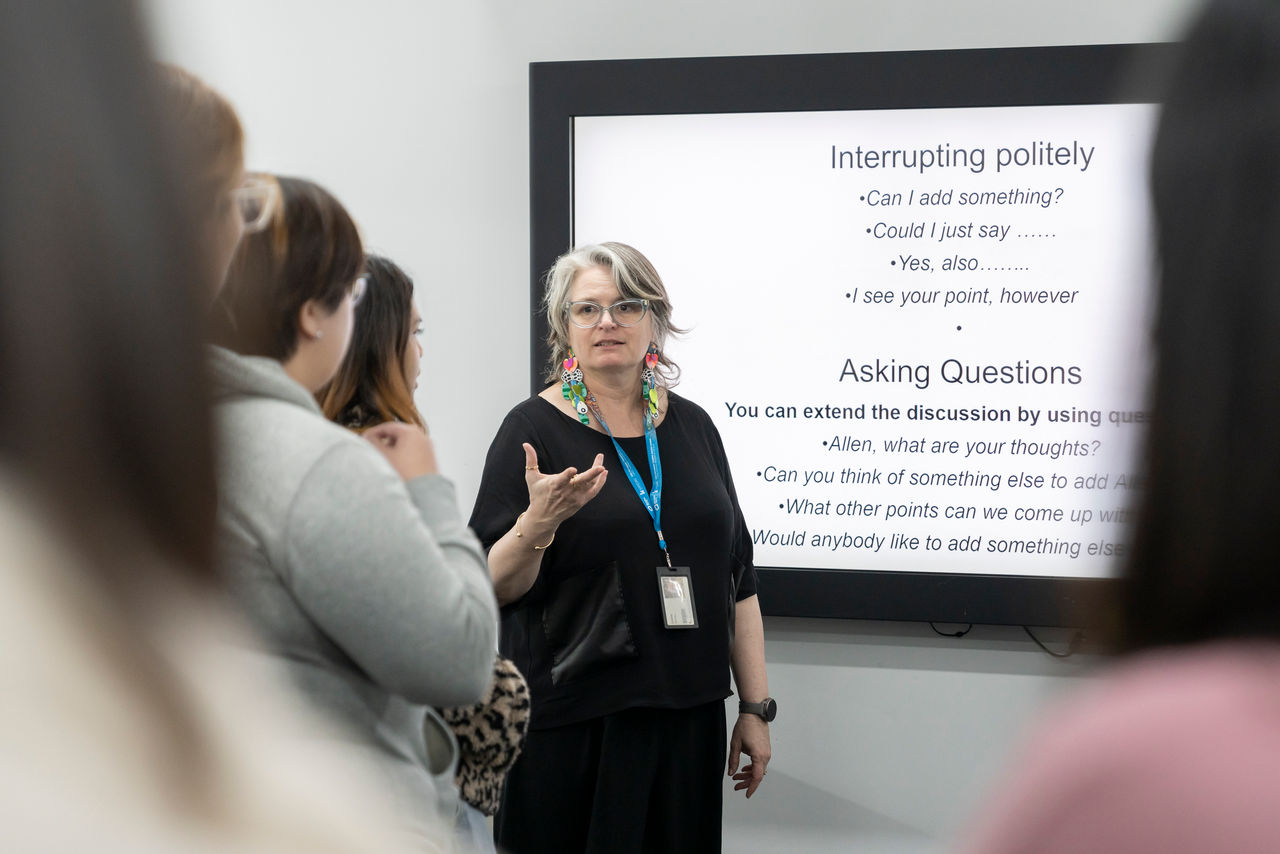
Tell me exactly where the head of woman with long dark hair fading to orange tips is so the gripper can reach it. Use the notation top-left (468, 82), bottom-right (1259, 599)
top-left (325, 255), bottom-right (426, 433)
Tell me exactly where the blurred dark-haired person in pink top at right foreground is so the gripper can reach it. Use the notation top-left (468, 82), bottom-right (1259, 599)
top-left (964, 0), bottom-right (1280, 854)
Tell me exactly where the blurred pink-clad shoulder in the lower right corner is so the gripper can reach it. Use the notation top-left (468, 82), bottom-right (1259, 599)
top-left (961, 643), bottom-right (1280, 854)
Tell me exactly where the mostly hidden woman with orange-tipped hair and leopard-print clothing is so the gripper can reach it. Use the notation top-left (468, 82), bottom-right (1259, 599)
top-left (325, 255), bottom-right (529, 851)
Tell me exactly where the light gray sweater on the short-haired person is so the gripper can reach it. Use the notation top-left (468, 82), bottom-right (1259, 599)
top-left (210, 347), bottom-right (497, 839)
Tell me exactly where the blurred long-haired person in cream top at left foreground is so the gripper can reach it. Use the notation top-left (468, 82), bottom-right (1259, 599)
top-left (0, 0), bottom-right (445, 853)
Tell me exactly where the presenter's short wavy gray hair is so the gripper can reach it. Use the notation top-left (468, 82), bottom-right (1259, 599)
top-left (543, 242), bottom-right (685, 388)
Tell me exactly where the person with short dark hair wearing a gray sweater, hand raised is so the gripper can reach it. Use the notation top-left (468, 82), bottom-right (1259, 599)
top-left (211, 178), bottom-right (497, 844)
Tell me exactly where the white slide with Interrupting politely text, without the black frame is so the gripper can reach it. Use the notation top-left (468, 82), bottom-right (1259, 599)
top-left (573, 104), bottom-right (1157, 577)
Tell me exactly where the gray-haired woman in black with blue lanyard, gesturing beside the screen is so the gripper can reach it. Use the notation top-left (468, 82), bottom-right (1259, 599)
top-left (471, 243), bottom-right (776, 854)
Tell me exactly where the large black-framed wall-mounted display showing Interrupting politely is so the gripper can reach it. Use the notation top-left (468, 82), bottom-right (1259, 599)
top-left (531, 45), bottom-right (1169, 625)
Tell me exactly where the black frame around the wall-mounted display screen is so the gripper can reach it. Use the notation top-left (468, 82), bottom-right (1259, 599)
top-left (530, 44), bottom-right (1172, 626)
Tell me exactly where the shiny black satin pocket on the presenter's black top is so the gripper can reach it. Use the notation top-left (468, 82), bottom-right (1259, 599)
top-left (543, 561), bottom-right (639, 685)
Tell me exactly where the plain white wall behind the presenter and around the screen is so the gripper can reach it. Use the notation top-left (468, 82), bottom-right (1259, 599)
top-left (145, 0), bottom-right (1194, 851)
